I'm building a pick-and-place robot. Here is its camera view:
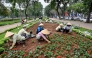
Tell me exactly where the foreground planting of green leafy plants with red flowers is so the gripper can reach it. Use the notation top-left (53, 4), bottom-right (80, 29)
top-left (1, 34), bottom-right (92, 58)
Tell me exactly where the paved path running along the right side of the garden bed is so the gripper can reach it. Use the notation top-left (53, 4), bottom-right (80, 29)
top-left (51, 18), bottom-right (92, 30)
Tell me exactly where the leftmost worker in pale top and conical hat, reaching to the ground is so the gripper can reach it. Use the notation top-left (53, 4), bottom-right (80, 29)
top-left (5, 32), bottom-right (25, 49)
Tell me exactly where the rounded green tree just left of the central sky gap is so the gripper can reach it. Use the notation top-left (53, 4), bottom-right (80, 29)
top-left (27, 1), bottom-right (43, 17)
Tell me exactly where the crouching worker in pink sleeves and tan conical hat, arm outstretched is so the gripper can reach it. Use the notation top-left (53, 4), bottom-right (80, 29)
top-left (36, 29), bottom-right (50, 43)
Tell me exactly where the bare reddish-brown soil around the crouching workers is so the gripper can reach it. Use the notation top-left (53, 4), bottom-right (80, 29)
top-left (6, 22), bottom-right (76, 52)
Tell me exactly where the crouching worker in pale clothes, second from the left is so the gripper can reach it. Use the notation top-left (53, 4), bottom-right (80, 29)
top-left (18, 25), bottom-right (35, 39)
